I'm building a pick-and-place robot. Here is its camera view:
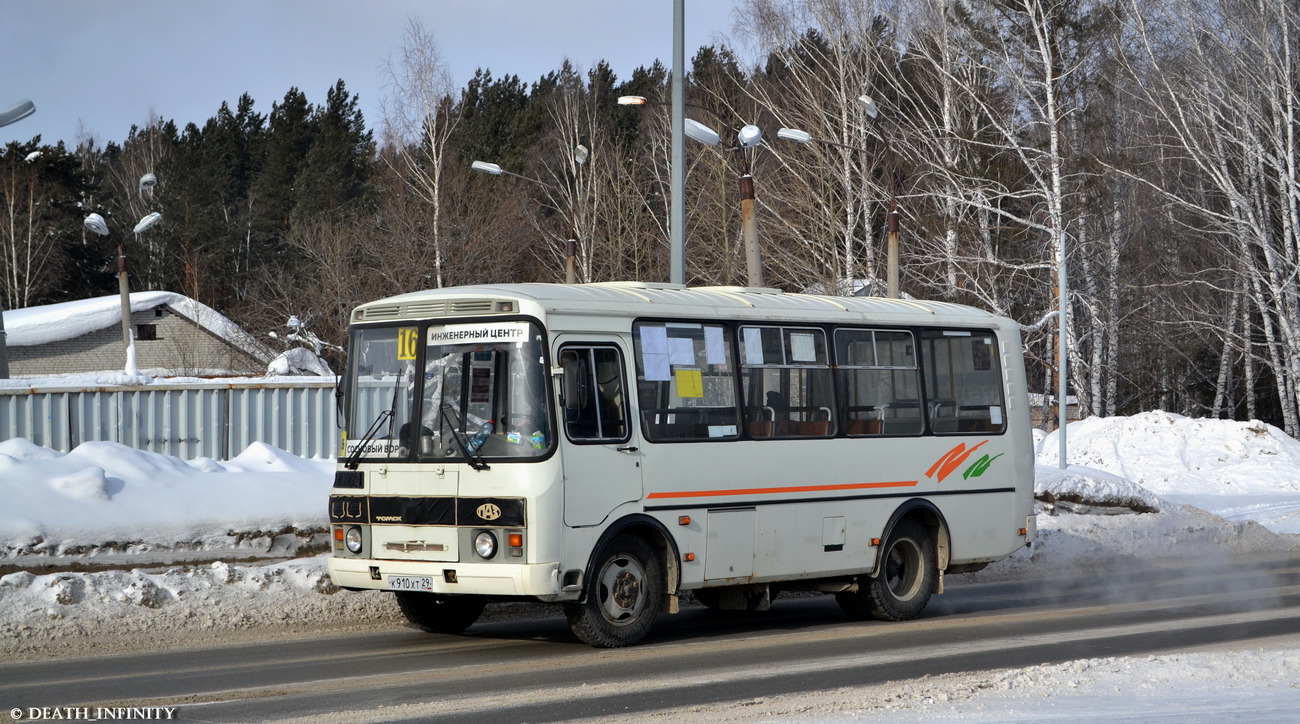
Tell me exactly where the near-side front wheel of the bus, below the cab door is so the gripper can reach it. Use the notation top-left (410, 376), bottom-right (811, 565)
top-left (564, 536), bottom-right (663, 649)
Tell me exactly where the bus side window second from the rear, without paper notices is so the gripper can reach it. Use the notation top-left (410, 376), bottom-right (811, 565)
top-left (835, 329), bottom-right (924, 437)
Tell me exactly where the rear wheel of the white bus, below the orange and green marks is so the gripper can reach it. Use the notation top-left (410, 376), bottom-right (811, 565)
top-left (835, 520), bottom-right (939, 621)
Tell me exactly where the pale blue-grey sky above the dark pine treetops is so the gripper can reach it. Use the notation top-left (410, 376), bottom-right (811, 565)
top-left (0, 0), bottom-right (742, 147)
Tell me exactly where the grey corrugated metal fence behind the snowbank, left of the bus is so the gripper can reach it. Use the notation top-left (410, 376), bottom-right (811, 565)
top-left (0, 378), bottom-right (338, 460)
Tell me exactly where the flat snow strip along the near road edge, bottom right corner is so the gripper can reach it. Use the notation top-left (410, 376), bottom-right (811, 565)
top-left (639, 649), bottom-right (1300, 724)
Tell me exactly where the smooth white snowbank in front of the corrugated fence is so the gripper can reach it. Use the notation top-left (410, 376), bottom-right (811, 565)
top-left (0, 438), bottom-right (334, 563)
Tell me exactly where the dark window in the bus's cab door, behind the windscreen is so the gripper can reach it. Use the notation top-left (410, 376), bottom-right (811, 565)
top-left (559, 346), bottom-right (628, 442)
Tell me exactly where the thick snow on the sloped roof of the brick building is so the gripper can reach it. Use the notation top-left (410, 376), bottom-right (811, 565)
top-left (4, 291), bottom-right (276, 363)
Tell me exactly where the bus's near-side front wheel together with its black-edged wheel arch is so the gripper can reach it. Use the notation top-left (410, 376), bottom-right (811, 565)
top-left (564, 519), bottom-right (676, 649)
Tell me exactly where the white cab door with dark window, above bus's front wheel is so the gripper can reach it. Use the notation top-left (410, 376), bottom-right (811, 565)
top-left (556, 335), bottom-right (641, 526)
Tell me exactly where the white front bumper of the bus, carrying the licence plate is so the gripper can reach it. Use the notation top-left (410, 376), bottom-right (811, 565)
top-left (329, 556), bottom-right (560, 598)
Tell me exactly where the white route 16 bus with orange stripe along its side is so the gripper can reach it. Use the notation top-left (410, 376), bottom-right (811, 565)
top-left (329, 282), bottom-right (1035, 647)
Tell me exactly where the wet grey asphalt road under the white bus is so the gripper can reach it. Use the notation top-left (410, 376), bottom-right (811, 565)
top-left (0, 558), bottom-right (1300, 724)
